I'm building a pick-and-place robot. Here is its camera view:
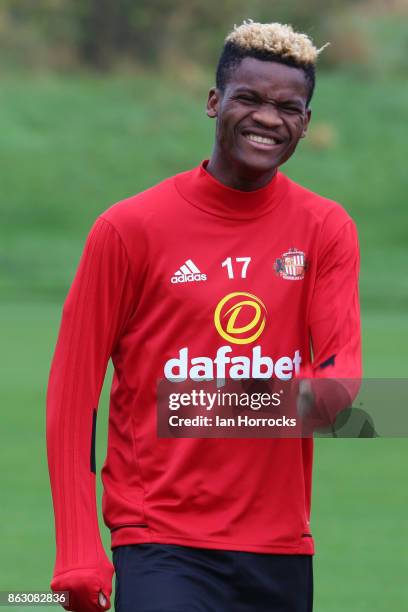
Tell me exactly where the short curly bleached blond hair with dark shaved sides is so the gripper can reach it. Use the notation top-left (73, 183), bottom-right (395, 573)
top-left (216, 19), bottom-right (327, 105)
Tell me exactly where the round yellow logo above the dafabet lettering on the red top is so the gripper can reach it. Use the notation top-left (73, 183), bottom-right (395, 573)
top-left (214, 291), bottom-right (266, 344)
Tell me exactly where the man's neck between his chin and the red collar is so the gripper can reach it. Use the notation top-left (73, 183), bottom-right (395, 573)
top-left (206, 150), bottom-right (277, 191)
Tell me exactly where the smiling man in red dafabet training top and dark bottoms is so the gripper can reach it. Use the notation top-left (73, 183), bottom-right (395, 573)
top-left (47, 22), bottom-right (361, 612)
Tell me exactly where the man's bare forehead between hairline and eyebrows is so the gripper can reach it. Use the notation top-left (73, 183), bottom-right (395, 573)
top-left (227, 57), bottom-right (308, 98)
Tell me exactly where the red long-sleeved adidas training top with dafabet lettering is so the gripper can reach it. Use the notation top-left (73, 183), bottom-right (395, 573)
top-left (47, 162), bottom-right (361, 604)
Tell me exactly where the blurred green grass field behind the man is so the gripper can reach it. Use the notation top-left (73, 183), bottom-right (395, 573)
top-left (0, 74), bottom-right (408, 612)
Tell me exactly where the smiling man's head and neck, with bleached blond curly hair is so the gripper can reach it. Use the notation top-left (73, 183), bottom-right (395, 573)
top-left (207, 23), bottom-right (319, 191)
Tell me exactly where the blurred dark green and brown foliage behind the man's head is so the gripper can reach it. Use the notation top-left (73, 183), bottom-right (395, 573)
top-left (0, 0), bottom-right (408, 70)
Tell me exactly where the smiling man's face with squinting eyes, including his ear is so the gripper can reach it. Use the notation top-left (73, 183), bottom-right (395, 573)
top-left (207, 57), bottom-right (311, 175)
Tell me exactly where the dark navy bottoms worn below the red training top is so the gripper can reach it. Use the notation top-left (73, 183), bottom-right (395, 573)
top-left (113, 544), bottom-right (313, 612)
